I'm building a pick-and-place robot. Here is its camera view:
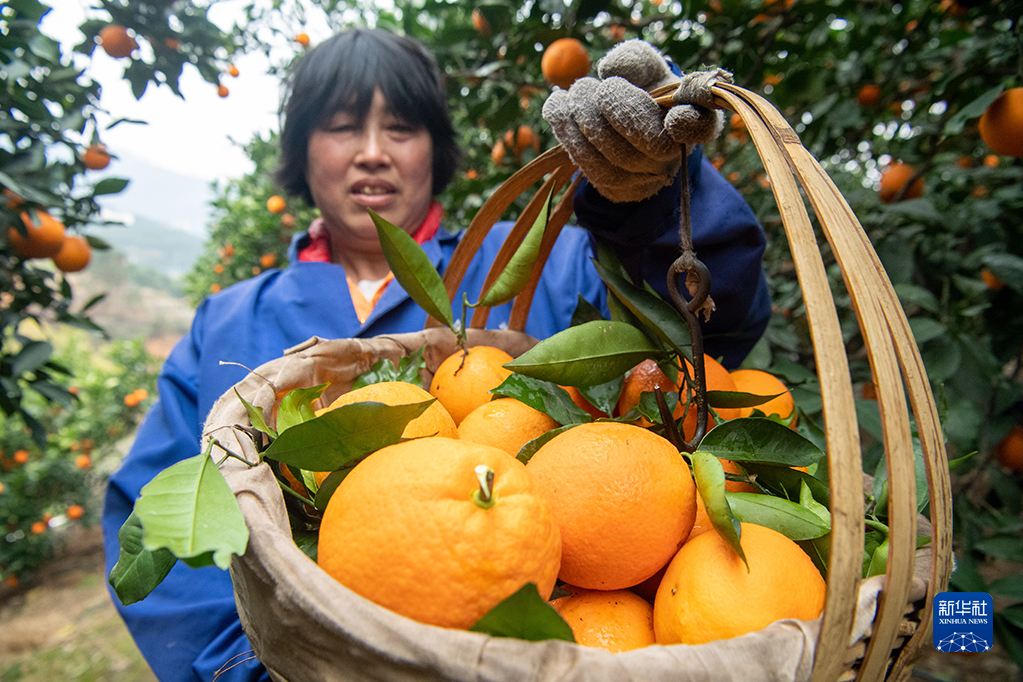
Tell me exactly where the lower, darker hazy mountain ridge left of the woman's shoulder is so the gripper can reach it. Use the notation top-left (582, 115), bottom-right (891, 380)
top-left (89, 216), bottom-right (206, 279)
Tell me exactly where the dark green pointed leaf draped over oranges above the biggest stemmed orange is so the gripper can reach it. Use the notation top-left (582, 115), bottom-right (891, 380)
top-left (264, 400), bottom-right (434, 471)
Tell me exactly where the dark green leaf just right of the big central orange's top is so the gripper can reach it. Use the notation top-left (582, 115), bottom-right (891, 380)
top-left (700, 417), bottom-right (824, 466)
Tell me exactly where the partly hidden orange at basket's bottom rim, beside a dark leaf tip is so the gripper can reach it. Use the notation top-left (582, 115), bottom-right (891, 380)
top-left (551, 588), bottom-right (657, 653)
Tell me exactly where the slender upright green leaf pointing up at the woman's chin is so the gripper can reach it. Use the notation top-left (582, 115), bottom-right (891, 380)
top-left (367, 209), bottom-right (454, 328)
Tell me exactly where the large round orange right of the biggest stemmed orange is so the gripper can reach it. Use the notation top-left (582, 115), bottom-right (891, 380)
top-left (527, 421), bottom-right (697, 590)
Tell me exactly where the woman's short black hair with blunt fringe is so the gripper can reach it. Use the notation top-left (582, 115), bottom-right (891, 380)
top-left (274, 29), bottom-right (461, 206)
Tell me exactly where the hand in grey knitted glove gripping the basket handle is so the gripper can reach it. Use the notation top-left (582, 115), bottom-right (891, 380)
top-left (542, 39), bottom-right (724, 202)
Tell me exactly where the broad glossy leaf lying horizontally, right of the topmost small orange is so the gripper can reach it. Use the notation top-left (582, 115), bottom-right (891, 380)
top-left (504, 320), bottom-right (661, 387)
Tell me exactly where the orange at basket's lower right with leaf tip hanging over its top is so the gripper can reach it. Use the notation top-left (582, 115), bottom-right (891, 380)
top-left (654, 524), bottom-right (826, 644)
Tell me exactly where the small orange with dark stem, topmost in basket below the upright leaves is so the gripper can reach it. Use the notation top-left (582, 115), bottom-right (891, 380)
top-left (430, 346), bottom-right (514, 424)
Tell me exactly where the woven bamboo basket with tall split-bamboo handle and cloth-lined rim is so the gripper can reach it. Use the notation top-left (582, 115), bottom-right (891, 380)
top-left (206, 83), bottom-right (952, 682)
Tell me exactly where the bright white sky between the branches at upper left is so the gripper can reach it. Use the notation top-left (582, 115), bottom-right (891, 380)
top-left (42, 0), bottom-right (279, 181)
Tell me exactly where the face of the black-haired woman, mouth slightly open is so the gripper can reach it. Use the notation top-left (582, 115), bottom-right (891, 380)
top-left (307, 89), bottom-right (434, 242)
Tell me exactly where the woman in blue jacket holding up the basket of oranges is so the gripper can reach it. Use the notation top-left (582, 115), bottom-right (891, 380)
top-left (103, 30), bottom-right (769, 682)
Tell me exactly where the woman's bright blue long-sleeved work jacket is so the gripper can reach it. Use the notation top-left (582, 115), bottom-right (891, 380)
top-left (102, 154), bottom-right (770, 682)
